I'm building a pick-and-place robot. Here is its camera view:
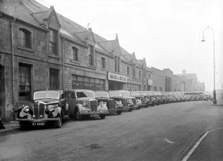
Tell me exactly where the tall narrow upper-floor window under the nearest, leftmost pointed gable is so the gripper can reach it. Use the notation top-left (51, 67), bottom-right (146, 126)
top-left (49, 29), bottom-right (57, 55)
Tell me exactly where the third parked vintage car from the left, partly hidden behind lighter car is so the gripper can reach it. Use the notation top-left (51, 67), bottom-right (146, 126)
top-left (94, 91), bottom-right (123, 115)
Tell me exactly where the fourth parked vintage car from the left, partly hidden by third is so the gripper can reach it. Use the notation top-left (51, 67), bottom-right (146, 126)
top-left (108, 90), bottom-right (134, 112)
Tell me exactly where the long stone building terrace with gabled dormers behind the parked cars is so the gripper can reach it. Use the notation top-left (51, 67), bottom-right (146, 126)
top-left (0, 0), bottom-right (206, 120)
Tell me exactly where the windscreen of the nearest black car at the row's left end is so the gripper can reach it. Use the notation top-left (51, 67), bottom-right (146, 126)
top-left (33, 91), bottom-right (60, 100)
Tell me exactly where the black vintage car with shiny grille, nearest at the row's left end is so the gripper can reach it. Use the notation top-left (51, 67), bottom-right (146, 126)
top-left (17, 90), bottom-right (69, 128)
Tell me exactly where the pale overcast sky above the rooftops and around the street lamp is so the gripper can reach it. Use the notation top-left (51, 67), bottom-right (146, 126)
top-left (37, 0), bottom-right (223, 90)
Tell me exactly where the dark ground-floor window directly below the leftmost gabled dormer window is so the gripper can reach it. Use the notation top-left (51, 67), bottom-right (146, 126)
top-left (50, 68), bottom-right (59, 89)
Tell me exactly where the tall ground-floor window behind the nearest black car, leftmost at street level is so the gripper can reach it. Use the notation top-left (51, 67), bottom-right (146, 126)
top-left (19, 64), bottom-right (31, 100)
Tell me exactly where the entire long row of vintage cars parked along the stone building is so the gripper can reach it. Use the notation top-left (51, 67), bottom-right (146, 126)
top-left (16, 89), bottom-right (211, 128)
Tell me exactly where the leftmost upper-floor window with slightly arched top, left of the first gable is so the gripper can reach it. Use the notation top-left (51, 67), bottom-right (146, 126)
top-left (19, 28), bottom-right (32, 48)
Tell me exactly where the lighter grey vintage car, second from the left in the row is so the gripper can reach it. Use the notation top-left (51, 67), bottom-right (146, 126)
top-left (64, 89), bottom-right (109, 120)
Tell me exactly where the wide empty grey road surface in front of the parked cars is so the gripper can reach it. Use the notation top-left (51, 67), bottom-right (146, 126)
top-left (0, 101), bottom-right (223, 161)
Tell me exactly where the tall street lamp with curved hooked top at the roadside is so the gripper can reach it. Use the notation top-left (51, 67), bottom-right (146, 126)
top-left (201, 26), bottom-right (217, 104)
